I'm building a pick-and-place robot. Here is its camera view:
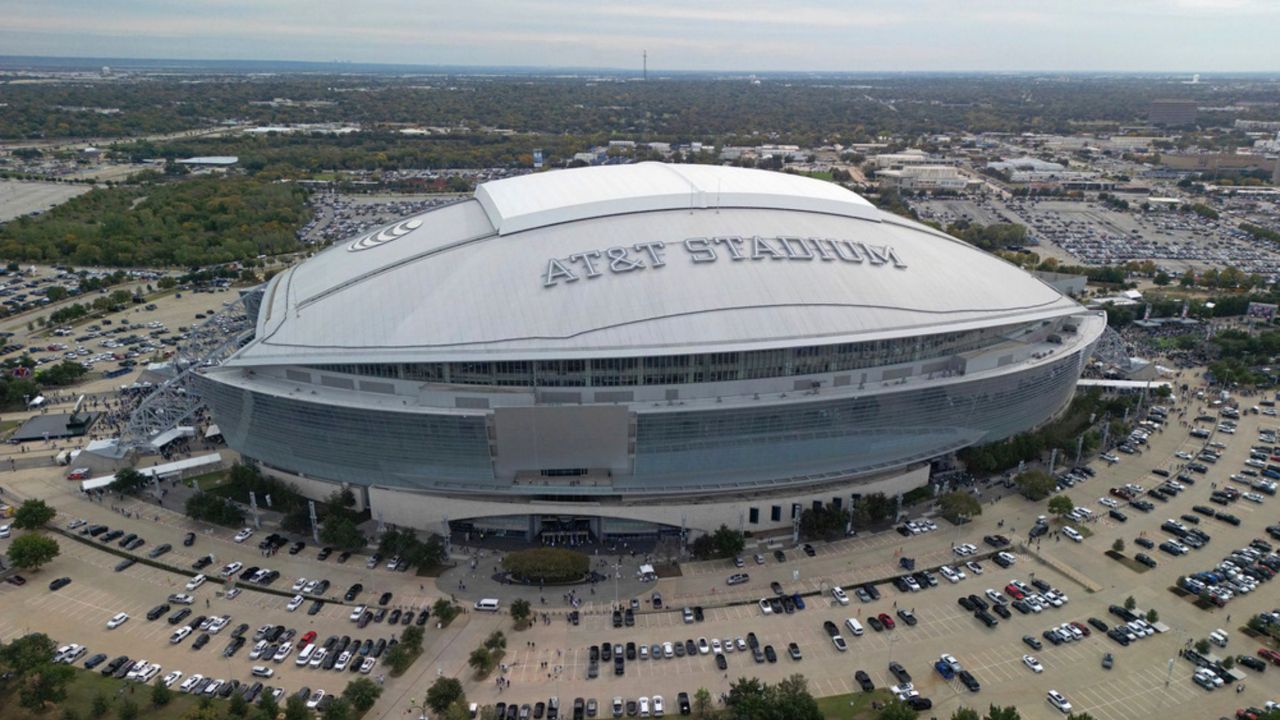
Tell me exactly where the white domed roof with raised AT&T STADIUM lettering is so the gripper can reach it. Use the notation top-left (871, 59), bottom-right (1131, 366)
top-left (229, 163), bottom-right (1082, 365)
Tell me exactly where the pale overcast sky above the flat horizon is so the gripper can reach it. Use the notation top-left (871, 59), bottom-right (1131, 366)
top-left (0, 0), bottom-right (1280, 72)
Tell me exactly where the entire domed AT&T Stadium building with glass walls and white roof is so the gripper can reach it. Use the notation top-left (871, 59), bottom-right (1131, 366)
top-left (197, 163), bottom-right (1106, 542)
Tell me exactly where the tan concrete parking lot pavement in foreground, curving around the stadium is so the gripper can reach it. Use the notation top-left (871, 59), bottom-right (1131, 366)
top-left (0, 363), bottom-right (1280, 720)
